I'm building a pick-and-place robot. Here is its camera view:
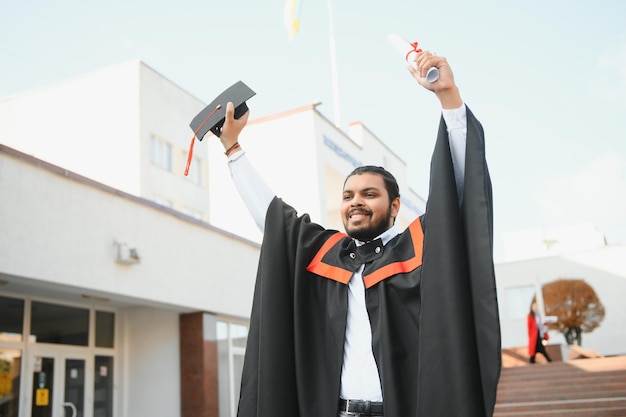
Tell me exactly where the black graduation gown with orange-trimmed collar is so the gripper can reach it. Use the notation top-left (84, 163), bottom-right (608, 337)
top-left (238, 105), bottom-right (501, 417)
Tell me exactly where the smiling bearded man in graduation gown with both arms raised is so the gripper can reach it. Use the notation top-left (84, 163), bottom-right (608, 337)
top-left (220, 52), bottom-right (501, 417)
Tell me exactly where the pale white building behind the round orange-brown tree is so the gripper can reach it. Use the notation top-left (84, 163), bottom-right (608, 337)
top-left (496, 224), bottom-right (626, 355)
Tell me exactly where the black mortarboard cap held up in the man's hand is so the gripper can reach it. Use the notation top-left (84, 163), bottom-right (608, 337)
top-left (189, 81), bottom-right (256, 140)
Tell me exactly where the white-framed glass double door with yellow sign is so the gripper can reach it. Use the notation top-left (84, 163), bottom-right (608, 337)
top-left (26, 349), bottom-right (91, 417)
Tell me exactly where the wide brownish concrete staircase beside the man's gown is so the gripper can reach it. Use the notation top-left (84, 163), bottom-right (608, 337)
top-left (494, 356), bottom-right (626, 417)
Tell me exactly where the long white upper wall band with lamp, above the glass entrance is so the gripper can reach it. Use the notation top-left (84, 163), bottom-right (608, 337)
top-left (0, 145), bottom-right (259, 317)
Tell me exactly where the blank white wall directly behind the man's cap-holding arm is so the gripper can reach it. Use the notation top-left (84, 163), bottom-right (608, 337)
top-left (202, 105), bottom-right (323, 241)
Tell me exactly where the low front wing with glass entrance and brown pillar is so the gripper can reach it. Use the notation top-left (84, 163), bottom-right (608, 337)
top-left (0, 145), bottom-right (259, 417)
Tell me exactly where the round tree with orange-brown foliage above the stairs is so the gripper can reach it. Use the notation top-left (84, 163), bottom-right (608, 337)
top-left (542, 279), bottom-right (604, 346)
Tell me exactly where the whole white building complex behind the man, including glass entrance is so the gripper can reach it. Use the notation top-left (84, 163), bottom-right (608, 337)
top-left (0, 61), bottom-right (424, 417)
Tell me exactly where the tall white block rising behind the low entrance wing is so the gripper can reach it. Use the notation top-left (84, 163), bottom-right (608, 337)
top-left (0, 61), bottom-right (209, 221)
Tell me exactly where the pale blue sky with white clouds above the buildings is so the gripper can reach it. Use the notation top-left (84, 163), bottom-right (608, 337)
top-left (0, 0), bottom-right (626, 260)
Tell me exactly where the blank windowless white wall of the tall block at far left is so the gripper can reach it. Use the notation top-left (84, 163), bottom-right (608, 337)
top-left (0, 62), bottom-right (140, 195)
